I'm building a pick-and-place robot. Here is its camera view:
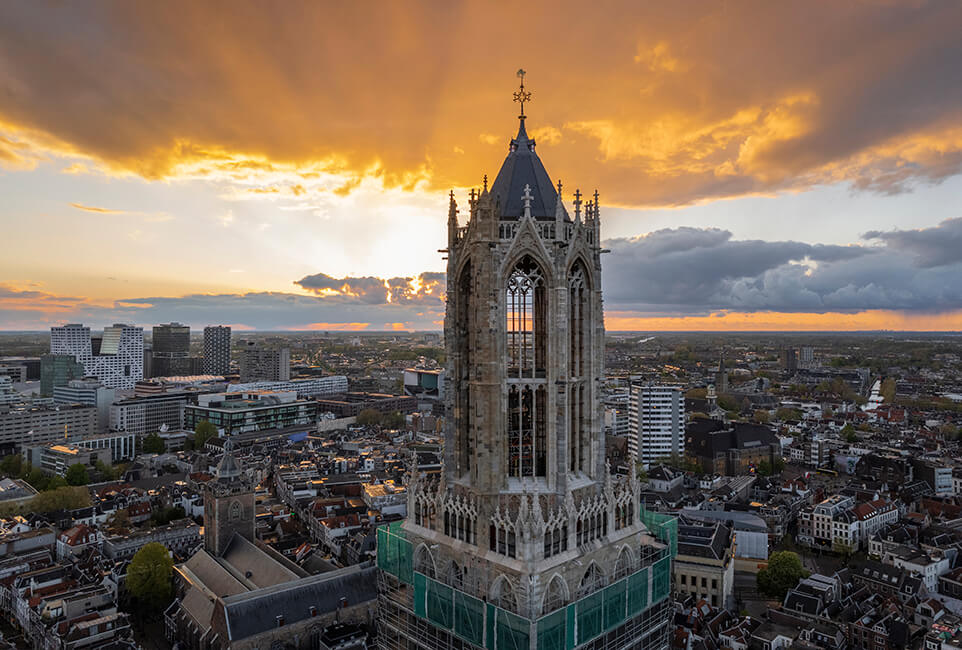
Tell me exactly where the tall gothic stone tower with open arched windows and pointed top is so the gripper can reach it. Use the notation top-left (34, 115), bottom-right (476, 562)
top-left (379, 77), bottom-right (667, 649)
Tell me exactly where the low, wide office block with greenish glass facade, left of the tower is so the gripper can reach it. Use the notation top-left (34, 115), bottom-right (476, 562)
top-left (184, 391), bottom-right (318, 437)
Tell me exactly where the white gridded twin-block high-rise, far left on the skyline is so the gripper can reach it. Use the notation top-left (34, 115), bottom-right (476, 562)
top-left (50, 324), bottom-right (144, 389)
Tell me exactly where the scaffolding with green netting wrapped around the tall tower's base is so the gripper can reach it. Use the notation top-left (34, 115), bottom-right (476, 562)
top-left (377, 510), bottom-right (678, 650)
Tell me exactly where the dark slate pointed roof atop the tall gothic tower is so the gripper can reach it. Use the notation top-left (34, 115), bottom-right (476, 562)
top-left (491, 118), bottom-right (558, 220)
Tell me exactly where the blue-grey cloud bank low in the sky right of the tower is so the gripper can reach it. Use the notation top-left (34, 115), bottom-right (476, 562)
top-left (604, 220), bottom-right (962, 314)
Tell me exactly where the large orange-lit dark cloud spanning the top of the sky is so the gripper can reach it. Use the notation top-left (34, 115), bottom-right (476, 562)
top-left (0, 0), bottom-right (962, 205)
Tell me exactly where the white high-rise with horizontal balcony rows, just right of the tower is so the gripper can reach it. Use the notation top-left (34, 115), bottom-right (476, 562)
top-left (628, 384), bottom-right (685, 468)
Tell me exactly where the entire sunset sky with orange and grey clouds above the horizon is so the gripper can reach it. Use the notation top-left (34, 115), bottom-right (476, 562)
top-left (0, 0), bottom-right (962, 330)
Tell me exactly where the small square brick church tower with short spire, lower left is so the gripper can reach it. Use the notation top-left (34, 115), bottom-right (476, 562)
top-left (204, 440), bottom-right (254, 556)
